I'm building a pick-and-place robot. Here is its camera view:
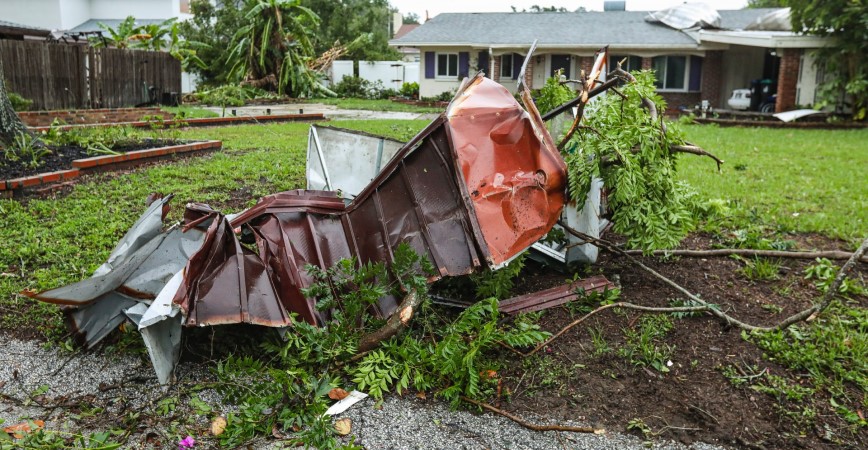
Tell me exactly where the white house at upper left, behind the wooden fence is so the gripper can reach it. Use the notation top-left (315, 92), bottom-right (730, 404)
top-left (0, 0), bottom-right (190, 32)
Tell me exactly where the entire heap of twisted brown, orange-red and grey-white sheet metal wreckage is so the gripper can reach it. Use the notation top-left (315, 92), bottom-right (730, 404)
top-left (28, 69), bottom-right (566, 383)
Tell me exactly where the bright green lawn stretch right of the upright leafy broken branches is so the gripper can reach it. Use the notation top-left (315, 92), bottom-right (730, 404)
top-left (679, 125), bottom-right (868, 240)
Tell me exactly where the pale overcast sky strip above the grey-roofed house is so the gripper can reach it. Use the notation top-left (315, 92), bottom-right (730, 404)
top-left (389, 0), bottom-right (747, 21)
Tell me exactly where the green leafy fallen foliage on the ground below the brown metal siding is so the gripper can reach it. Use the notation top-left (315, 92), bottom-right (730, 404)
top-left (217, 245), bottom-right (549, 449)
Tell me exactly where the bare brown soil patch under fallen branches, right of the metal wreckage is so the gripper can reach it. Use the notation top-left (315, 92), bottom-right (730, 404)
top-left (484, 235), bottom-right (868, 449)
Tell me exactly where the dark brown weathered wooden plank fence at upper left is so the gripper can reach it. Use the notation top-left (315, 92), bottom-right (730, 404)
top-left (0, 40), bottom-right (181, 110)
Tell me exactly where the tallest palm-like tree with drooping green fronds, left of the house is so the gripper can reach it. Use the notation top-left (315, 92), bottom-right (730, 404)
top-left (228, 0), bottom-right (330, 97)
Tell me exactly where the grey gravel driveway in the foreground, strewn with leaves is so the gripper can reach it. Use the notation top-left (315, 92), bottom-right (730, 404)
top-left (0, 338), bottom-right (723, 450)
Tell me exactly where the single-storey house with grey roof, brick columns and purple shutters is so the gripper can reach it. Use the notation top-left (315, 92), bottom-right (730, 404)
top-left (390, 6), bottom-right (828, 112)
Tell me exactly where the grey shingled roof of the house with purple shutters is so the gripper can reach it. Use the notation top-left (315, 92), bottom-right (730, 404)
top-left (389, 8), bottom-right (774, 48)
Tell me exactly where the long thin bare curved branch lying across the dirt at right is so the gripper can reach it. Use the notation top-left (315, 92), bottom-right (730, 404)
top-left (558, 221), bottom-right (868, 331)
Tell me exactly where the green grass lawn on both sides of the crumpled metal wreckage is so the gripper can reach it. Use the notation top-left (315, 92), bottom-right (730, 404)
top-left (0, 120), bottom-right (868, 333)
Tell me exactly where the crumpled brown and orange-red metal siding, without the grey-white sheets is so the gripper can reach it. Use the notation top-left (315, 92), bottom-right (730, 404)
top-left (174, 76), bottom-right (566, 326)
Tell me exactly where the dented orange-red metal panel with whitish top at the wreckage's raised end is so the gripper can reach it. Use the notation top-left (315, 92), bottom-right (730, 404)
top-left (447, 77), bottom-right (566, 265)
